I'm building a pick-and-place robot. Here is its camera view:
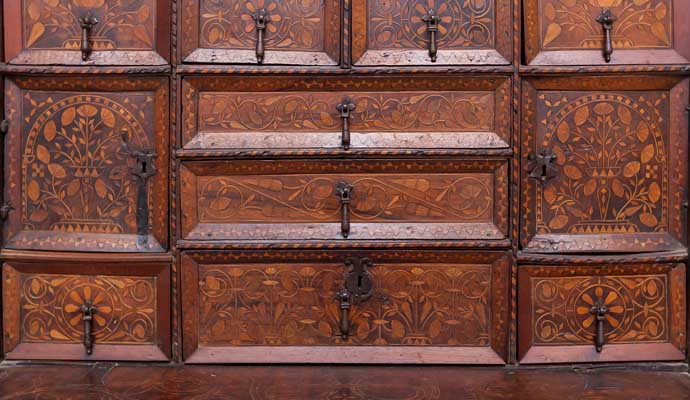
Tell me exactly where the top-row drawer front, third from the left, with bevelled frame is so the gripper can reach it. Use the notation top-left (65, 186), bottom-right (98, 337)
top-left (352, 0), bottom-right (513, 66)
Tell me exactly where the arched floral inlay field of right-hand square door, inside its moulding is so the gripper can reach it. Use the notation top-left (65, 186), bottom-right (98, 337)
top-left (537, 94), bottom-right (668, 234)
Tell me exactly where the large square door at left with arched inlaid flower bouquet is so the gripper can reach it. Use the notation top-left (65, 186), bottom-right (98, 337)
top-left (4, 77), bottom-right (169, 252)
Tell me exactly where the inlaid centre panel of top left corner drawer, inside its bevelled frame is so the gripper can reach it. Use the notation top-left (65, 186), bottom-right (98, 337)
top-left (22, 0), bottom-right (156, 50)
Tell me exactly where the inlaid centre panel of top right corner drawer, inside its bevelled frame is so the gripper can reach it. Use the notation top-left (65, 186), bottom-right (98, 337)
top-left (539, 0), bottom-right (672, 50)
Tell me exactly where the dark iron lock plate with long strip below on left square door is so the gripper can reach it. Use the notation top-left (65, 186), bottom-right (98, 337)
top-left (122, 132), bottom-right (158, 247)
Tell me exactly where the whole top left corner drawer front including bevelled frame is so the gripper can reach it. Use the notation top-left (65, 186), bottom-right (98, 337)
top-left (4, 0), bottom-right (170, 65)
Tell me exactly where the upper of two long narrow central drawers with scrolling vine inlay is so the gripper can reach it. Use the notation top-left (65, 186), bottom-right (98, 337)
top-left (182, 77), bottom-right (511, 151)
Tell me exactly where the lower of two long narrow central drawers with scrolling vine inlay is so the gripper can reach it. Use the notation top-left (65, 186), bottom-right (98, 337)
top-left (180, 160), bottom-right (508, 241)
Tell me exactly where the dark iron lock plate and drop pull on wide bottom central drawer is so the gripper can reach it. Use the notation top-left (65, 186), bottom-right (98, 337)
top-left (336, 257), bottom-right (374, 339)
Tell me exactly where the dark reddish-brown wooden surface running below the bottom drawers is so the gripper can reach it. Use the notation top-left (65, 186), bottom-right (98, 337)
top-left (0, 364), bottom-right (690, 400)
